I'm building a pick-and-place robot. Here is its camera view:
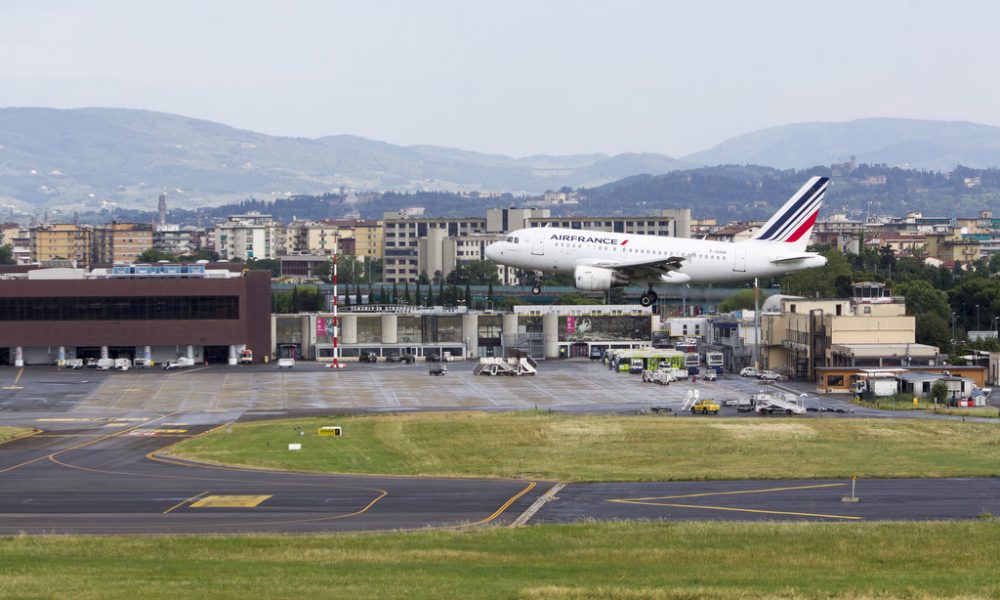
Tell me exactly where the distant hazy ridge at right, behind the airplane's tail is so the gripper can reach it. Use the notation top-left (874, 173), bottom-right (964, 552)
top-left (683, 118), bottom-right (1000, 171)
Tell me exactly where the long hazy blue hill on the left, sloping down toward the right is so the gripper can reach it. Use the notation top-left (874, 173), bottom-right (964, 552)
top-left (0, 108), bottom-right (685, 211)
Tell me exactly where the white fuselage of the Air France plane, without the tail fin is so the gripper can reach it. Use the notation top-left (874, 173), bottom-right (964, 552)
top-left (486, 227), bottom-right (826, 284)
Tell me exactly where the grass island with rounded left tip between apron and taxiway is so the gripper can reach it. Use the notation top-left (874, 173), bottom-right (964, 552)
top-left (171, 412), bottom-right (1000, 481)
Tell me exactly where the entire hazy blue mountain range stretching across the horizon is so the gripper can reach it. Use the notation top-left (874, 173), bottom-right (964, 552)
top-left (0, 108), bottom-right (1000, 219)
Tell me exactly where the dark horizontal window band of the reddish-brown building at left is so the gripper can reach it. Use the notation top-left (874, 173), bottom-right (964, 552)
top-left (0, 296), bottom-right (240, 321)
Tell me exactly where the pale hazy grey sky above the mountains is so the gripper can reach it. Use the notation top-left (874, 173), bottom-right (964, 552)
top-left (0, 0), bottom-right (1000, 156)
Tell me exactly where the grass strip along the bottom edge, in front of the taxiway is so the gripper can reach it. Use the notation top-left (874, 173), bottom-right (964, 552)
top-left (0, 520), bottom-right (1000, 600)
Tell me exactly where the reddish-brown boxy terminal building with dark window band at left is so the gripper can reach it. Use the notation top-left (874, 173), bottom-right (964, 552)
top-left (0, 261), bottom-right (271, 366)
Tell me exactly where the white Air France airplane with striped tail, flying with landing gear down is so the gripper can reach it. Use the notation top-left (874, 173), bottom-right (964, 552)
top-left (486, 177), bottom-right (830, 306)
